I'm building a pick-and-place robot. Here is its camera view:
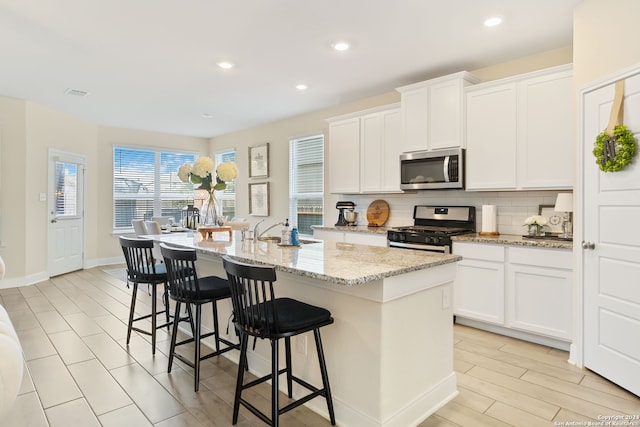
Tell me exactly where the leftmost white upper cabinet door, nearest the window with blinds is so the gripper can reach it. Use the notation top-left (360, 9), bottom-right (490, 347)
top-left (326, 118), bottom-right (360, 194)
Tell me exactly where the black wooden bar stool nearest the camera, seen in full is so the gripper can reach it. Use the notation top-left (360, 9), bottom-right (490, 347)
top-left (222, 255), bottom-right (336, 427)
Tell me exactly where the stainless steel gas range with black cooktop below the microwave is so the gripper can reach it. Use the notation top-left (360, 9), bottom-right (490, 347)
top-left (387, 206), bottom-right (476, 254)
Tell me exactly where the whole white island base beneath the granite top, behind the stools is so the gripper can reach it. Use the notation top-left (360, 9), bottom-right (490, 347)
top-left (192, 254), bottom-right (455, 427)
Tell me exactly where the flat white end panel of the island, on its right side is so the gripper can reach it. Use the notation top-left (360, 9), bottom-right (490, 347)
top-left (381, 272), bottom-right (457, 426)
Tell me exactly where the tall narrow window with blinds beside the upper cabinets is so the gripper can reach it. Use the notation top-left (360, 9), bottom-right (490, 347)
top-left (289, 135), bottom-right (324, 236)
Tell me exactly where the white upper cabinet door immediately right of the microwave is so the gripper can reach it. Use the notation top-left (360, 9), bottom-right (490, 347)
top-left (466, 83), bottom-right (517, 190)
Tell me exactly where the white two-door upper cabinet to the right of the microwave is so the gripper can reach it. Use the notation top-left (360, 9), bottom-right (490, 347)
top-left (465, 65), bottom-right (574, 190)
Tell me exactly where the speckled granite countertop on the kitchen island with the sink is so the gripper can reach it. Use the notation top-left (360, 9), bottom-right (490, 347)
top-left (144, 232), bottom-right (462, 286)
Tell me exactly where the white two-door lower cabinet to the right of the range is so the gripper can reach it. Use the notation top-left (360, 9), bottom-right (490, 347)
top-left (453, 242), bottom-right (573, 345)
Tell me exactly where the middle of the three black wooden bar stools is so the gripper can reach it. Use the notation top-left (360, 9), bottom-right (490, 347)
top-left (160, 243), bottom-right (240, 391)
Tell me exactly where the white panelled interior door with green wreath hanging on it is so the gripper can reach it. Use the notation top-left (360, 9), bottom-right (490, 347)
top-left (581, 69), bottom-right (640, 395)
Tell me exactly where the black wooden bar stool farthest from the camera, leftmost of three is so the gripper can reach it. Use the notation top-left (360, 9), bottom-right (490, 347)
top-left (120, 236), bottom-right (171, 354)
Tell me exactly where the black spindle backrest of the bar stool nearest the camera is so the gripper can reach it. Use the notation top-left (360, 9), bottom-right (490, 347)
top-left (222, 255), bottom-right (279, 338)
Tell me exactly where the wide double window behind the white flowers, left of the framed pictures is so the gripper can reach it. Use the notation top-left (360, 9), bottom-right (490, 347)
top-left (113, 147), bottom-right (197, 230)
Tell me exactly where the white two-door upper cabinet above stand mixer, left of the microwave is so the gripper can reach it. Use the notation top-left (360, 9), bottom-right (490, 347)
top-left (326, 104), bottom-right (401, 194)
